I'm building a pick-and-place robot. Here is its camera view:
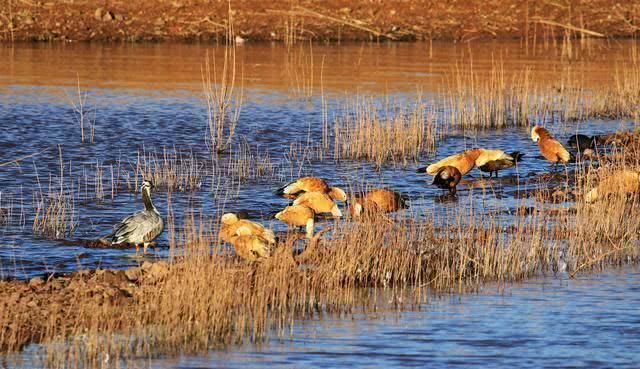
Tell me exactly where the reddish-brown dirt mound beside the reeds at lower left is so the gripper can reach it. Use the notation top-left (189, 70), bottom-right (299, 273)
top-left (0, 262), bottom-right (169, 352)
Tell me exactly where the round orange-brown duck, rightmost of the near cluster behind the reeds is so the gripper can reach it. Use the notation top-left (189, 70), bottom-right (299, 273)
top-left (349, 188), bottom-right (408, 218)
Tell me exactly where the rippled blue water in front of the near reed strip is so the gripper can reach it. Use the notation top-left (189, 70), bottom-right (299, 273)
top-left (151, 268), bottom-right (640, 369)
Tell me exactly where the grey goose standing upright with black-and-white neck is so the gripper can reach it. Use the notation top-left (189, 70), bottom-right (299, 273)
top-left (106, 181), bottom-right (164, 253)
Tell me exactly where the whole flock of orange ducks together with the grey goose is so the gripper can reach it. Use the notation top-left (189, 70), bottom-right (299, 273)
top-left (106, 126), bottom-right (640, 261)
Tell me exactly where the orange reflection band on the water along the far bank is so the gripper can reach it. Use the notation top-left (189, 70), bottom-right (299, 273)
top-left (0, 41), bottom-right (633, 94)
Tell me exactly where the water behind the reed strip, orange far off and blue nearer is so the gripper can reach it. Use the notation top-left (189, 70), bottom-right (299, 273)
top-left (0, 43), bottom-right (631, 278)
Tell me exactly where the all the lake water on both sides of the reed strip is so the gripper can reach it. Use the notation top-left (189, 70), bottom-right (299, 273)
top-left (0, 42), bottom-right (640, 368)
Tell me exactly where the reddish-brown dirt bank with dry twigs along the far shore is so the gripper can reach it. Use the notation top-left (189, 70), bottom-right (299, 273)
top-left (0, 0), bottom-right (640, 42)
